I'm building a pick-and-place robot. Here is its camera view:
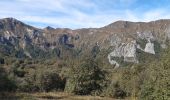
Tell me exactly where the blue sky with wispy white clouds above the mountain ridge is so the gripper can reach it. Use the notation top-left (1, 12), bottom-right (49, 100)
top-left (0, 0), bottom-right (170, 29)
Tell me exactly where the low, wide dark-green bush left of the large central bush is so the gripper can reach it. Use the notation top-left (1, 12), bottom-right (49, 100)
top-left (19, 69), bottom-right (65, 92)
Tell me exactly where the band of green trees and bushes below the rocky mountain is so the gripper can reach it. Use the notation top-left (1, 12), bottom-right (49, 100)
top-left (0, 49), bottom-right (170, 100)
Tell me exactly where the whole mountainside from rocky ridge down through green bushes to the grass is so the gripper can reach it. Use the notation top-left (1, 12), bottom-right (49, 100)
top-left (0, 18), bottom-right (170, 100)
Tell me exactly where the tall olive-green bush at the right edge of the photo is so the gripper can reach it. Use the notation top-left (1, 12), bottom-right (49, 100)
top-left (140, 50), bottom-right (170, 100)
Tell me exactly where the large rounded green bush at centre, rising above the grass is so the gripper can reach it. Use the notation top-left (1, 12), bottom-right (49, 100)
top-left (65, 58), bottom-right (106, 95)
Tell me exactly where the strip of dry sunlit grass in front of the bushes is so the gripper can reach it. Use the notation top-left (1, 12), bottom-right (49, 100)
top-left (0, 92), bottom-right (117, 100)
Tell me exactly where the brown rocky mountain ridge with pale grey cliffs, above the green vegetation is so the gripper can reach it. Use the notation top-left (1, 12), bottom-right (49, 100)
top-left (0, 18), bottom-right (170, 67)
